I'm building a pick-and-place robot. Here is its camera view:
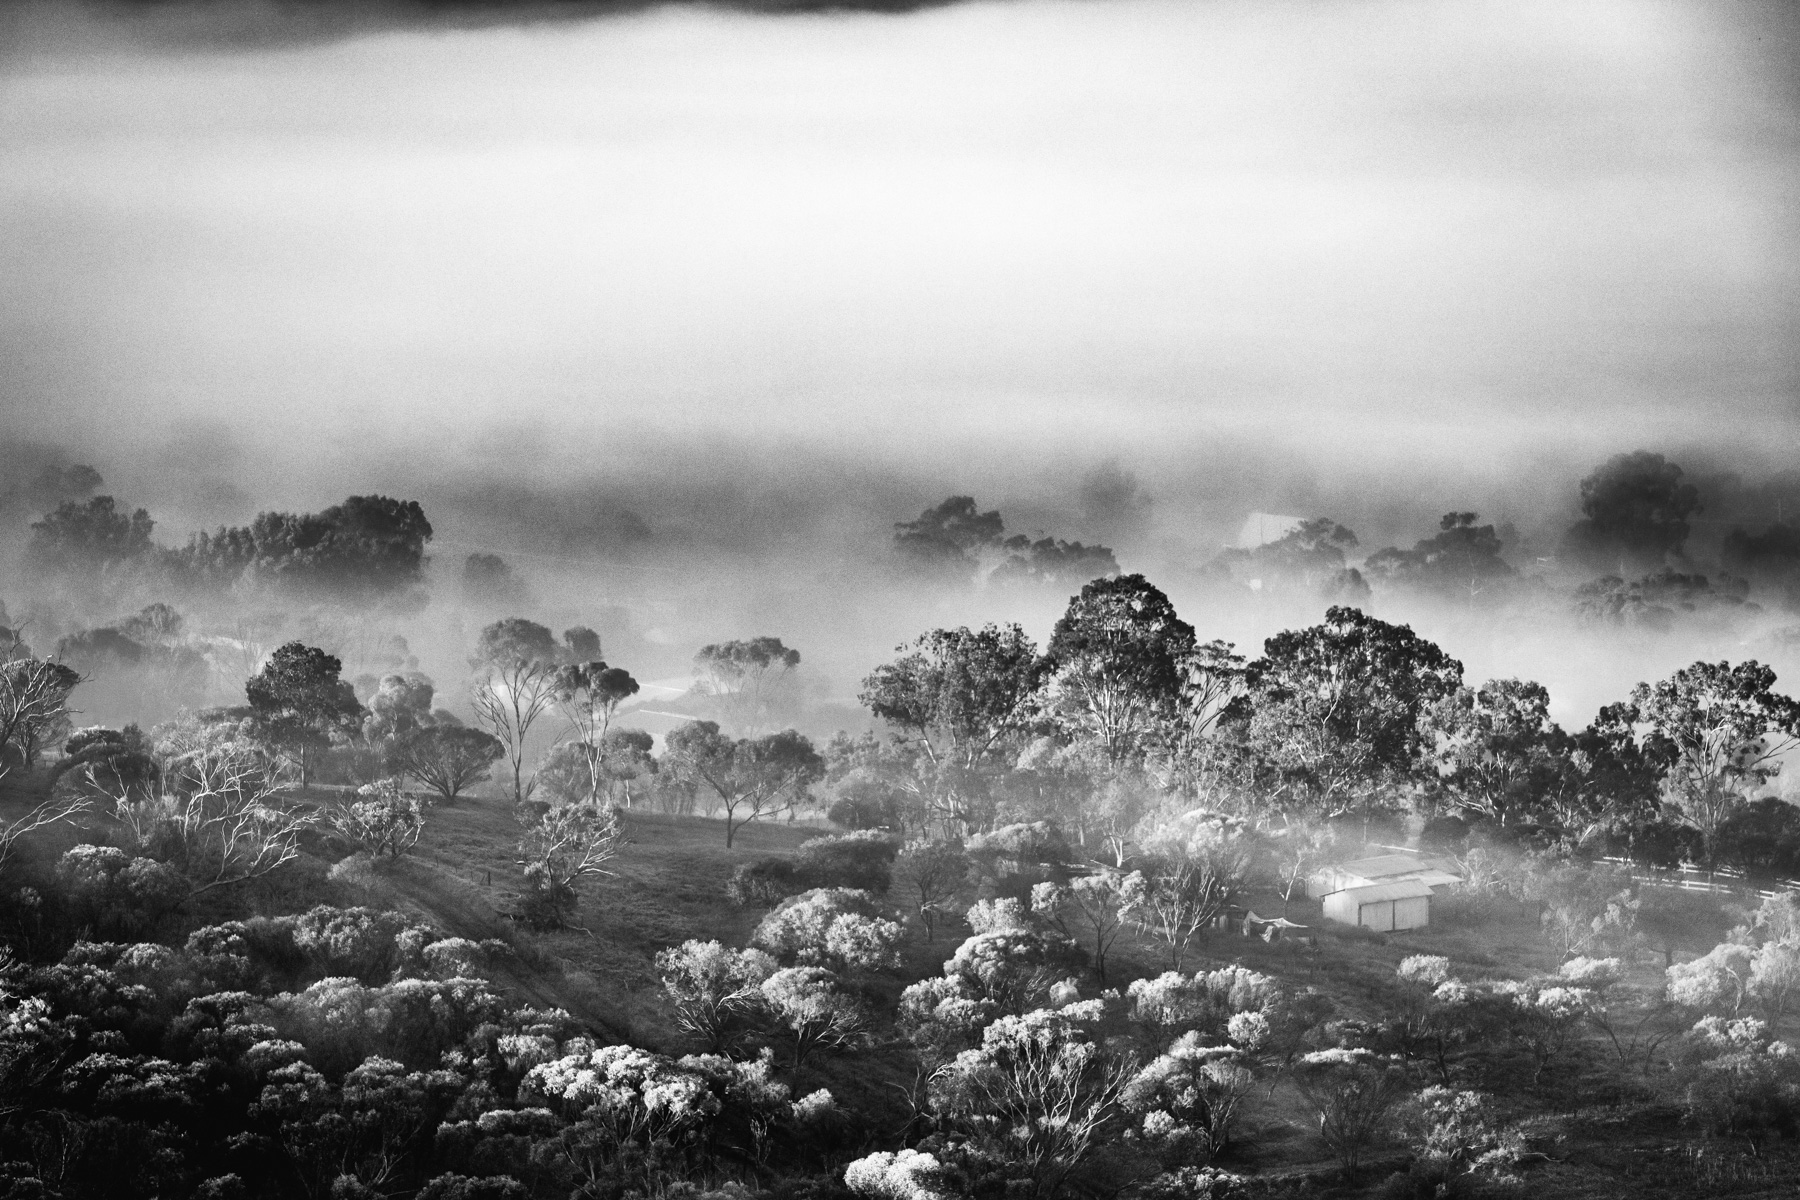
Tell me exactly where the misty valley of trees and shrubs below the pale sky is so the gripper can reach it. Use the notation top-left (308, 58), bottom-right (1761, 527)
top-left (0, 452), bottom-right (1800, 1200)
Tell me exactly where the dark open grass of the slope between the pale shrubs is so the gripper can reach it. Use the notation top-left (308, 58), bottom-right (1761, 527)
top-left (14, 766), bottom-right (1800, 1200)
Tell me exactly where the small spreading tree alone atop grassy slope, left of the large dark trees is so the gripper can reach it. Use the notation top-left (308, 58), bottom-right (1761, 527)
top-left (664, 721), bottom-right (824, 849)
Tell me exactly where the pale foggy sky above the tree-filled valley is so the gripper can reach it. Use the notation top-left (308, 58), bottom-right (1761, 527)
top-left (0, 0), bottom-right (1800, 534)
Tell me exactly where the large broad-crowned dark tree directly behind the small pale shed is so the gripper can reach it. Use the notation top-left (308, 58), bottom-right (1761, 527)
top-left (1246, 606), bottom-right (1462, 817)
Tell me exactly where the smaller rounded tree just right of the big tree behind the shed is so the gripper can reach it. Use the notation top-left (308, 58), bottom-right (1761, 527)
top-left (1427, 680), bottom-right (1568, 826)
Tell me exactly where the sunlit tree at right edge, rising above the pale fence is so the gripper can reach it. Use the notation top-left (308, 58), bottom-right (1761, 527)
top-left (1631, 658), bottom-right (1800, 867)
